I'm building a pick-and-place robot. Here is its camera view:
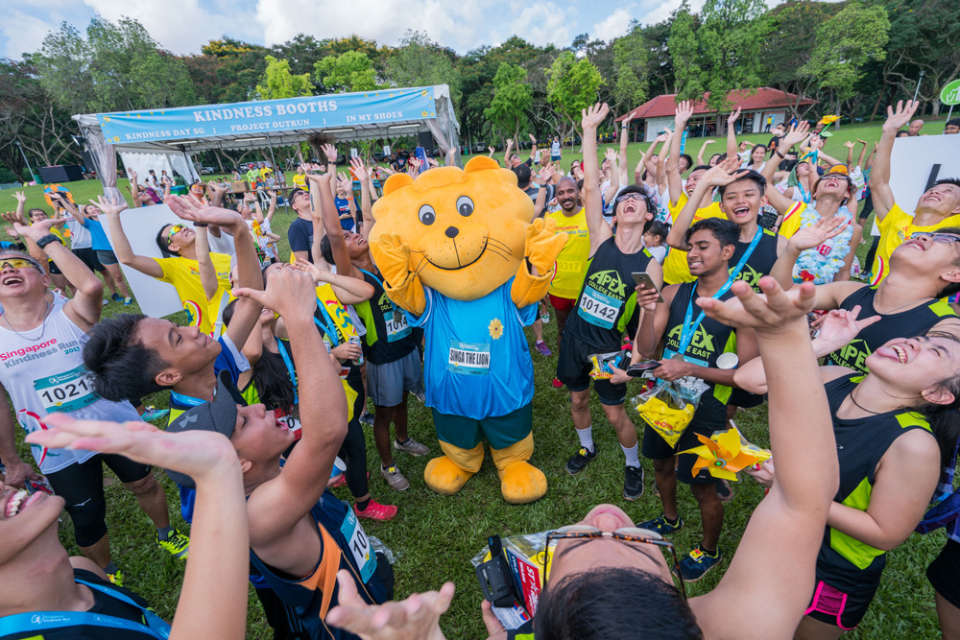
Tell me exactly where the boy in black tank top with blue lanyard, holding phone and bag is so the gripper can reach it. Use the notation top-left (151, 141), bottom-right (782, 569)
top-left (638, 218), bottom-right (757, 582)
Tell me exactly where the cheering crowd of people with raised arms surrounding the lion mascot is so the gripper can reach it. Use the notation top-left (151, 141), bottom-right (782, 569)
top-left (0, 96), bottom-right (960, 640)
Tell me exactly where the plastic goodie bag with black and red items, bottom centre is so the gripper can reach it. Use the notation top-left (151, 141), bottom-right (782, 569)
top-left (470, 531), bottom-right (550, 633)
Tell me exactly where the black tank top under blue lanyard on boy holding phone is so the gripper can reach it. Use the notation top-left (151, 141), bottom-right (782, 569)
top-left (663, 280), bottom-right (737, 426)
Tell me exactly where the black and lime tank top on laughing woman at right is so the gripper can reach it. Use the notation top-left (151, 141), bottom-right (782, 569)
top-left (817, 374), bottom-right (933, 588)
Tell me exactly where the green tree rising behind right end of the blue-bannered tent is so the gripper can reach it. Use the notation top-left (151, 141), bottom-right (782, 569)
top-left (385, 31), bottom-right (462, 108)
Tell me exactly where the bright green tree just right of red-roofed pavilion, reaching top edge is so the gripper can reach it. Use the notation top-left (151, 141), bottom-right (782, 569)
top-left (800, 1), bottom-right (890, 113)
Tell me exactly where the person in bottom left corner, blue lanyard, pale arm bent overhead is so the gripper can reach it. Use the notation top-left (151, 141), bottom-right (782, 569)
top-left (0, 413), bottom-right (249, 640)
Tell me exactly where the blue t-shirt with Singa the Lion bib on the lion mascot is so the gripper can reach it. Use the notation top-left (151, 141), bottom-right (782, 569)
top-left (405, 278), bottom-right (537, 420)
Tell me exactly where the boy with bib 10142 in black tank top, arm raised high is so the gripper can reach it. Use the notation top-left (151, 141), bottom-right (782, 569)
top-left (557, 104), bottom-right (663, 500)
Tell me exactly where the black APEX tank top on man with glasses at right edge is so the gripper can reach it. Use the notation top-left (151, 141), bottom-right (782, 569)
top-left (830, 286), bottom-right (957, 373)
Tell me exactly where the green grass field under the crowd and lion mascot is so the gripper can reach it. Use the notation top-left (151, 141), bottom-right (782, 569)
top-left (0, 119), bottom-right (944, 639)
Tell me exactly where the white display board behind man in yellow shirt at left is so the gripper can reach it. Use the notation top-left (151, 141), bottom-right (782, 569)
top-left (101, 204), bottom-right (195, 318)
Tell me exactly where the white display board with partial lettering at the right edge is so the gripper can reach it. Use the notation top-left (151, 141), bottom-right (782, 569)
top-left (890, 135), bottom-right (960, 214)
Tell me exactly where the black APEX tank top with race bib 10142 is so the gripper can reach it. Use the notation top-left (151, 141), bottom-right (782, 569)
top-left (564, 236), bottom-right (652, 351)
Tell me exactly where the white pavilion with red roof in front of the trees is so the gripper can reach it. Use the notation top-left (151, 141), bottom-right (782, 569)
top-left (617, 87), bottom-right (816, 142)
